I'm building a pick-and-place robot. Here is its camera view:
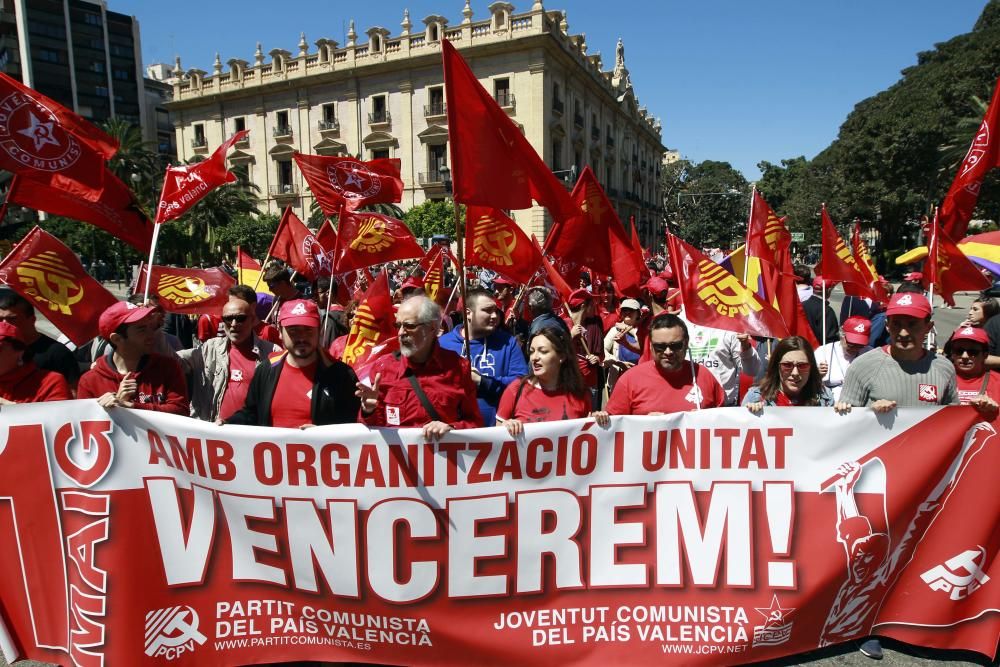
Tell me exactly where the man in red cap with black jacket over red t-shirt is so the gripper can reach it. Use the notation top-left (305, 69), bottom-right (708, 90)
top-left (225, 299), bottom-right (361, 428)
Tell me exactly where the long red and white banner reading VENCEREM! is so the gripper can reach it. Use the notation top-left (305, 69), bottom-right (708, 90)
top-left (0, 401), bottom-right (1000, 667)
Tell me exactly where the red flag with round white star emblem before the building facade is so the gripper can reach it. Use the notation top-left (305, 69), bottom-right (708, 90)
top-left (292, 153), bottom-right (403, 216)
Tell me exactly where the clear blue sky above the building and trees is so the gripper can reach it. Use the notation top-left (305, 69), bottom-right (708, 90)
top-left (115, 0), bottom-right (990, 179)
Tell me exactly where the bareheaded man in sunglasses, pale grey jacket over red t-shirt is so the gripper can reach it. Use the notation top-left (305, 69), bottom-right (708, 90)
top-left (177, 285), bottom-right (275, 422)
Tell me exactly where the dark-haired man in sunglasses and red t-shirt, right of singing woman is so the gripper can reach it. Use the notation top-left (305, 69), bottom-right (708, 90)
top-left (607, 313), bottom-right (726, 415)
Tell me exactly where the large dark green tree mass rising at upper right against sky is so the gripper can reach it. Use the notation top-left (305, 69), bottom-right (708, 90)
top-left (758, 0), bottom-right (1000, 268)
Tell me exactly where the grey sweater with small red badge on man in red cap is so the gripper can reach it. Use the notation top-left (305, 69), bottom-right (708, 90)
top-left (840, 349), bottom-right (959, 408)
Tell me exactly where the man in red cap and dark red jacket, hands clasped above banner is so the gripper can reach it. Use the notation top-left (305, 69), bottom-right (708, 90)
top-left (77, 301), bottom-right (188, 416)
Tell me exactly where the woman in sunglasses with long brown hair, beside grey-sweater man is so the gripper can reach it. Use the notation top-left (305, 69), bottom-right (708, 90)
top-left (743, 336), bottom-right (833, 414)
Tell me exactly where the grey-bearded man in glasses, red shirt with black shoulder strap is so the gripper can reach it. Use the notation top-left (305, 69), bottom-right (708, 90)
top-left (357, 294), bottom-right (483, 440)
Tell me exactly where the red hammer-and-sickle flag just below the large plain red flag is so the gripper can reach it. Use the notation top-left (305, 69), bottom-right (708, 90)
top-left (465, 206), bottom-right (542, 283)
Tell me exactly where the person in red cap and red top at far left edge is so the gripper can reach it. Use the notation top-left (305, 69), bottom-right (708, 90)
top-left (0, 322), bottom-right (73, 405)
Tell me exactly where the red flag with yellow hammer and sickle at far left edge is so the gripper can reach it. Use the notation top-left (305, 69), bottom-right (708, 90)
top-left (0, 227), bottom-right (118, 345)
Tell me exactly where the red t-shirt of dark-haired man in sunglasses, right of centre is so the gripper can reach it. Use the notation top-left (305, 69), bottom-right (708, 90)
top-left (607, 361), bottom-right (726, 415)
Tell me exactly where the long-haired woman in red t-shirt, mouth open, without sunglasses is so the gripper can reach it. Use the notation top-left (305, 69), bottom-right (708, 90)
top-left (497, 327), bottom-right (609, 437)
